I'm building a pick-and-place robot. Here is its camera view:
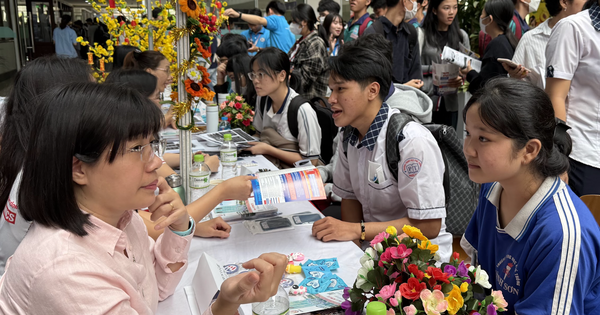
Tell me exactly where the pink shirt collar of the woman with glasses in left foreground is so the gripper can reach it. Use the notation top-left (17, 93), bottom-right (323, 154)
top-left (85, 210), bottom-right (133, 256)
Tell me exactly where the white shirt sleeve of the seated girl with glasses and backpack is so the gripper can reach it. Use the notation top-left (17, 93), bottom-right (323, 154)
top-left (298, 103), bottom-right (321, 160)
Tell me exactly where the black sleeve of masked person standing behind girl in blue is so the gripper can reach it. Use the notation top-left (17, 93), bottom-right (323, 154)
top-left (467, 41), bottom-right (512, 94)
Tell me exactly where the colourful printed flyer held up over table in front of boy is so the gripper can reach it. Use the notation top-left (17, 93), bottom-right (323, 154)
top-left (252, 165), bottom-right (327, 205)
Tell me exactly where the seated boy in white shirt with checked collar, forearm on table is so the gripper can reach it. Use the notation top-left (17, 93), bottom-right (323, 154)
top-left (312, 34), bottom-right (452, 261)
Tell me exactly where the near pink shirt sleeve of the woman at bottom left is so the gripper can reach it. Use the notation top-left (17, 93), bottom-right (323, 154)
top-left (26, 255), bottom-right (138, 315)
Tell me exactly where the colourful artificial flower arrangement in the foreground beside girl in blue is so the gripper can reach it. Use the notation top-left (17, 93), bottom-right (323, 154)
top-left (342, 225), bottom-right (508, 315)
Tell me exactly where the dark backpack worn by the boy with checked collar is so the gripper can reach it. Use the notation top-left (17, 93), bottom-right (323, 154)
top-left (342, 113), bottom-right (479, 236)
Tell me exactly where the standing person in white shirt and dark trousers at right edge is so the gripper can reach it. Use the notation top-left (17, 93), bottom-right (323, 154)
top-left (546, 1), bottom-right (600, 196)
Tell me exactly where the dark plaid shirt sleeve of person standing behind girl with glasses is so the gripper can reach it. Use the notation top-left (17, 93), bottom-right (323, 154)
top-left (294, 40), bottom-right (327, 91)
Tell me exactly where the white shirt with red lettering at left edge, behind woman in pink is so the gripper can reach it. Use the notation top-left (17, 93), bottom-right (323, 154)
top-left (0, 171), bottom-right (31, 275)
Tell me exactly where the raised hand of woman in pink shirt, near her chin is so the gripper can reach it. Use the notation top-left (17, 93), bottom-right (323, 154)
top-left (148, 177), bottom-right (190, 231)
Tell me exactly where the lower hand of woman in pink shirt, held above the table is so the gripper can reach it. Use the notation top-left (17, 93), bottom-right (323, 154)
top-left (211, 253), bottom-right (288, 315)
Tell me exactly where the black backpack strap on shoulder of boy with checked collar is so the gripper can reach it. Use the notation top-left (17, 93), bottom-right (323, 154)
top-left (385, 113), bottom-right (414, 182)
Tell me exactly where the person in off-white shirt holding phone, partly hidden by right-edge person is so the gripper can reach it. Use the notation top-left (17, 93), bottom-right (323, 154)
top-left (502, 0), bottom-right (586, 89)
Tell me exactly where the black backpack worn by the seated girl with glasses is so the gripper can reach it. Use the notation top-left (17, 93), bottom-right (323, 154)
top-left (256, 95), bottom-right (338, 164)
